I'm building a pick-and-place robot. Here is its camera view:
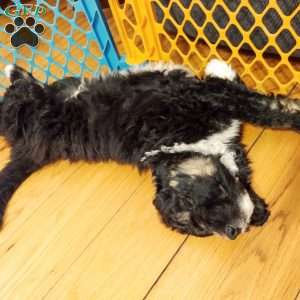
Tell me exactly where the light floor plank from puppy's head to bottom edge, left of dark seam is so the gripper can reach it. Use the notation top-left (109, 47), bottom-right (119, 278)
top-left (46, 175), bottom-right (185, 299)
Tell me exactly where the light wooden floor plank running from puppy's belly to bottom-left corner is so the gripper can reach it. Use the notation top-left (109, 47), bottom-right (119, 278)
top-left (0, 164), bottom-right (143, 299)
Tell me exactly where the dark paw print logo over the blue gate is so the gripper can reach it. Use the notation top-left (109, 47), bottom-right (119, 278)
top-left (4, 17), bottom-right (45, 47)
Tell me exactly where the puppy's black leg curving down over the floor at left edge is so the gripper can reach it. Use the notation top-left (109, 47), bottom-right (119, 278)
top-left (0, 157), bottom-right (39, 227)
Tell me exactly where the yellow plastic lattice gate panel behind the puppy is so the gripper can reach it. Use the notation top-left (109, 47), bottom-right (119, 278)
top-left (109, 0), bottom-right (300, 93)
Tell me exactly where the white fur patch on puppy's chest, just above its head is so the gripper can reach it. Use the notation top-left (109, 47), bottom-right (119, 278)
top-left (142, 120), bottom-right (241, 175)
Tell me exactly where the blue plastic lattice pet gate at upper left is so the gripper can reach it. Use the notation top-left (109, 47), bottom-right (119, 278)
top-left (0, 0), bottom-right (127, 96)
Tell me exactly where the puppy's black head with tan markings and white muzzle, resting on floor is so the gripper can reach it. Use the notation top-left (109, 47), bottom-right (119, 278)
top-left (154, 155), bottom-right (254, 239)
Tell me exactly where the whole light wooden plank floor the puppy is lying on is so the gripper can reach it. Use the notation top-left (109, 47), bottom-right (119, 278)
top-left (0, 4), bottom-right (300, 300)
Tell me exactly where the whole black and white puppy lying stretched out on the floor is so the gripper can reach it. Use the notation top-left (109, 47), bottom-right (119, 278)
top-left (0, 60), bottom-right (300, 239)
